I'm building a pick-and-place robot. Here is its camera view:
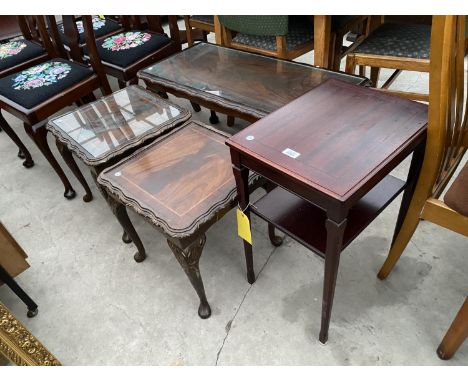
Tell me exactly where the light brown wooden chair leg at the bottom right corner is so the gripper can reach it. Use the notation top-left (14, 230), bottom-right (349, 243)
top-left (437, 297), bottom-right (468, 360)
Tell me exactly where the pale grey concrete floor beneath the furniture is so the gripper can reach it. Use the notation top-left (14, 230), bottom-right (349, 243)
top-left (0, 25), bottom-right (468, 365)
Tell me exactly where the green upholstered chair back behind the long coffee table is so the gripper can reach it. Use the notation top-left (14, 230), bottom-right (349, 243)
top-left (218, 15), bottom-right (289, 36)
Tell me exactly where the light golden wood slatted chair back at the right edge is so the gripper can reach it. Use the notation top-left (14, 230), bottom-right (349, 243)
top-left (421, 16), bottom-right (468, 197)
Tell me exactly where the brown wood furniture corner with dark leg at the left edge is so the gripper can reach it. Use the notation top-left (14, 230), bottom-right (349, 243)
top-left (0, 222), bottom-right (37, 317)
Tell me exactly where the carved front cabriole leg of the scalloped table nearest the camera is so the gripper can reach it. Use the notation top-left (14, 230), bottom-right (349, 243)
top-left (167, 235), bottom-right (211, 318)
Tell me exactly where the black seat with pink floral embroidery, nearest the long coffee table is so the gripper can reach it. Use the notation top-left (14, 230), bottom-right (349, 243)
top-left (84, 31), bottom-right (171, 68)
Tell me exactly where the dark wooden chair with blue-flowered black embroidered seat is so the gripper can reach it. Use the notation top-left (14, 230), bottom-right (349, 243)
top-left (0, 16), bottom-right (111, 199)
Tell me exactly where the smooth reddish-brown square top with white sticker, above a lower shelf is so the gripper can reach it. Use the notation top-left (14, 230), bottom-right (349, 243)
top-left (226, 79), bottom-right (427, 201)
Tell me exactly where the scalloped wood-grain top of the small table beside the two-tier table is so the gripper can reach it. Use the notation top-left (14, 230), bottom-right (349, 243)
top-left (98, 121), bottom-right (256, 237)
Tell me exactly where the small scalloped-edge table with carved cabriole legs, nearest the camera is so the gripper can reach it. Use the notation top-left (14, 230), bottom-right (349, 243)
top-left (98, 121), bottom-right (255, 318)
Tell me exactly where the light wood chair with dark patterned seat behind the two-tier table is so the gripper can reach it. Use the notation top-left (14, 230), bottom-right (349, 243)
top-left (346, 17), bottom-right (431, 101)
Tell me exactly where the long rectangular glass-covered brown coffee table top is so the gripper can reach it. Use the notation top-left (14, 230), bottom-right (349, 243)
top-left (138, 43), bottom-right (368, 119)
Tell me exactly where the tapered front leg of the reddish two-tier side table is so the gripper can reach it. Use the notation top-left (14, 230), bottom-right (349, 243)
top-left (319, 218), bottom-right (346, 343)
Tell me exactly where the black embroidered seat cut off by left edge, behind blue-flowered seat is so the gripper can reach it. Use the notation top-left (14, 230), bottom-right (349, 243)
top-left (0, 39), bottom-right (46, 72)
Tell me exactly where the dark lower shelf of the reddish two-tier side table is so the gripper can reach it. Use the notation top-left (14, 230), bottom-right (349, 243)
top-left (251, 175), bottom-right (405, 257)
